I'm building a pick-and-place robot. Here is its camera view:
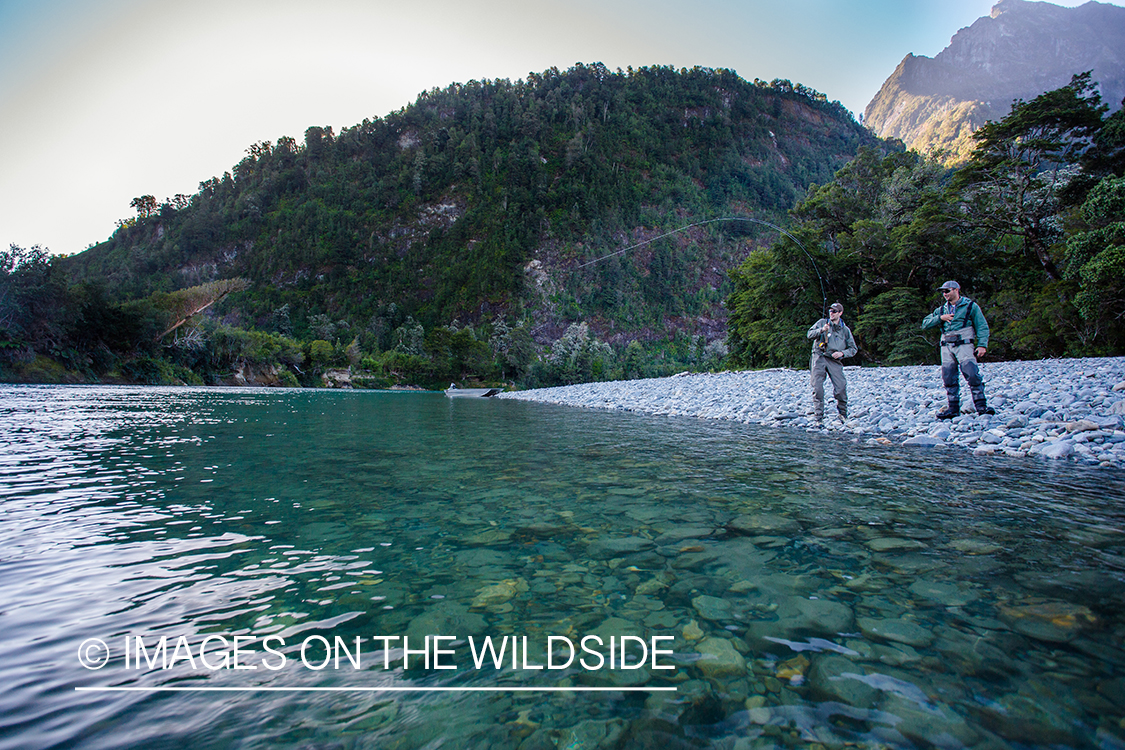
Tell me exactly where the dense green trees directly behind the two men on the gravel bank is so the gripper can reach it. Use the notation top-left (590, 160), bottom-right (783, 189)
top-left (728, 73), bottom-right (1125, 367)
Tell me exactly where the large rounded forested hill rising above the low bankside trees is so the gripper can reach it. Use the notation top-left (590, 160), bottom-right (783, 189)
top-left (61, 65), bottom-right (874, 333)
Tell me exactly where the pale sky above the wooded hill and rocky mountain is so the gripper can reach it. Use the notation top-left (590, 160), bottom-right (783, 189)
top-left (0, 0), bottom-right (1119, 254)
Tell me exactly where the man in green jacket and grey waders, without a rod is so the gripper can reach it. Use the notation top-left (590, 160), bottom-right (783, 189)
top-left (921, 281), bottom-right (996, 419)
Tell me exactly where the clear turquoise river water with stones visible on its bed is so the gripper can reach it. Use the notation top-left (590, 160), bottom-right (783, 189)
top-left (0, 387), bottom-right (1125, 750)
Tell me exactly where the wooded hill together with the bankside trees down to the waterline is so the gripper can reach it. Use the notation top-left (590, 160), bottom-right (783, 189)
top-left (0, 64), bottom-right (879, 386)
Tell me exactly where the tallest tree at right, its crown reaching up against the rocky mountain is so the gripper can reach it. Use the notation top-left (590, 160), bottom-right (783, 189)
top-left (953, 71), bottom-right (1106, 280)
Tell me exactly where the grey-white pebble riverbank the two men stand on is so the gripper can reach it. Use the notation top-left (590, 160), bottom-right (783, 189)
top-left (500, 356), bottom-right (1125, 469)
